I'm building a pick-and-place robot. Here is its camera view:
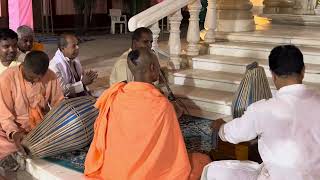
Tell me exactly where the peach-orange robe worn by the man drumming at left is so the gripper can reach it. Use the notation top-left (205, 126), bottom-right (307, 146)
top-left (0, 66), bottom-right (64, 159)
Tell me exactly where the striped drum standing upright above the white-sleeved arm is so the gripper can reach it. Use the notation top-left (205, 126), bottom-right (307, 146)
top-left (231, 62), bottom-right (272, 118)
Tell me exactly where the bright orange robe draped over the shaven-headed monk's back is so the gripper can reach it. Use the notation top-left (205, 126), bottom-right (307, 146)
top-left (85, 82), bottom-right (191, 180)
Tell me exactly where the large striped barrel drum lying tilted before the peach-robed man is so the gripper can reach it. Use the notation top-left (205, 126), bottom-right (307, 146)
top-left (22, 96), bottom-right (99, 158)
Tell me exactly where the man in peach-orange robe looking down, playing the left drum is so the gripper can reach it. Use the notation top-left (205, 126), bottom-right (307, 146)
top-left (0, 51), bottom-right (64, 174)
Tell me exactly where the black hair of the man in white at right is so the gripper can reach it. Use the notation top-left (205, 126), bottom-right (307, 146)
top-left (269, 45), bottom-right (304, 76)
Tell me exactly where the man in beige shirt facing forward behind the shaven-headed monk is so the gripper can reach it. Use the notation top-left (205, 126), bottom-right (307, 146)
top-left (110, 27), bottom-right (153, 86)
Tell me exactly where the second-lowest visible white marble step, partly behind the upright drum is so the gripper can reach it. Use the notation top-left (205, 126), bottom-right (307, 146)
top-left (169, 69), bottom-right (320, 93)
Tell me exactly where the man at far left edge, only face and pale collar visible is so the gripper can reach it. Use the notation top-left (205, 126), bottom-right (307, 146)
top-left (0, 28), bottom-right (20, 74)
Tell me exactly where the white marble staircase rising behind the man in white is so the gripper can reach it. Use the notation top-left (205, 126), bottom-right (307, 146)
top-left (169, 32), bottom-right (320, 120)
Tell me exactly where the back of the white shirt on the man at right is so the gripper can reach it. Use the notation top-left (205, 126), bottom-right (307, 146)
top-left (255, 84), bottom-right (320, 180)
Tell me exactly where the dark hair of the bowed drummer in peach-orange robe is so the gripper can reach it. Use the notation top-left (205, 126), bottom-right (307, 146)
top-left (23, 51), bottom-right (49, 75)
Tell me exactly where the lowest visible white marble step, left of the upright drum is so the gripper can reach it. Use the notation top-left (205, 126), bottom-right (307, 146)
top-left (171, 85), bottom-right (234, 117)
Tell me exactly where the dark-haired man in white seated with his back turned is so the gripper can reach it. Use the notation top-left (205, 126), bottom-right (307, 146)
top-left (202, 45), bottom-right (320, 180)
